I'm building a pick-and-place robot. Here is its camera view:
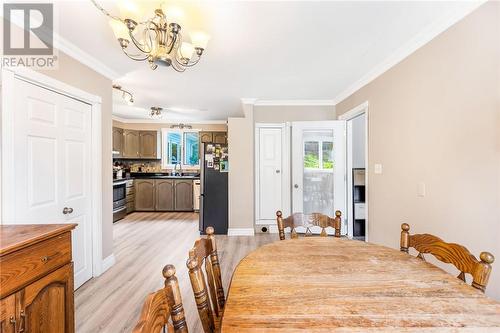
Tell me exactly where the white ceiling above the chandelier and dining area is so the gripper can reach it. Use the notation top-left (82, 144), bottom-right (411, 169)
top-left (58, 0), bottom-right (477, 121)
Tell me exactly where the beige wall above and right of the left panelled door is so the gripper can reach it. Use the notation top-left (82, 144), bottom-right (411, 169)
top-left (41, 51), bottom-right (113, 258)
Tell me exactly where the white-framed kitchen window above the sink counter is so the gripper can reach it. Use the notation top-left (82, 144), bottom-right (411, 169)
top-left (162, 129), bottom-right (200, 168)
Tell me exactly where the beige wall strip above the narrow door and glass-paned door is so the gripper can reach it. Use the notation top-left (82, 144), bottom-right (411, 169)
top-left (254, 105), bottom-right (336, 123)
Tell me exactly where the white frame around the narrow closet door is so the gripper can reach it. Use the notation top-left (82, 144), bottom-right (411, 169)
top-left (254, 123), bottom-right (291, 233)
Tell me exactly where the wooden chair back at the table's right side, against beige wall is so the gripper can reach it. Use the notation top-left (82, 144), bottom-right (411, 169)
top-left (400, 223), bottom-right (495, 292)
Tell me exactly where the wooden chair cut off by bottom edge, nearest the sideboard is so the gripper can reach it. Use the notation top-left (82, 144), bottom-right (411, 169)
top-left (133, 265), bottom-right (188, 333)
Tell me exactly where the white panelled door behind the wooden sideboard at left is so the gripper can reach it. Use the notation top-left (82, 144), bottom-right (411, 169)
top-left (9, 79), bottom-right (92, 288)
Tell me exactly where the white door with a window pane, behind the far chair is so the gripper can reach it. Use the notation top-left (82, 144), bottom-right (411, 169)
top-left (292, 120), bottom-right (346, 233)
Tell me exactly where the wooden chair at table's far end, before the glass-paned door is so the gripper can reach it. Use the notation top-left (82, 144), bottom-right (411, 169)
top-left (276, 210), bottom-right (342, 240)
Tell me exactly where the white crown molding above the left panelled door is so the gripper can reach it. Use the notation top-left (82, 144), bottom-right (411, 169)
top-left (2, 7), bottom-right (121, 80)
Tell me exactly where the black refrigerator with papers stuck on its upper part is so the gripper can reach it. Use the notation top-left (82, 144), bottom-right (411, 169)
top-left (200, 143), bottom-right (229, 235)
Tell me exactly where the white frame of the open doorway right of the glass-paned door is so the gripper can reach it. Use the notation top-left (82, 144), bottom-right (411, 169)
top-left (338, 101), bottom-right (369, 242)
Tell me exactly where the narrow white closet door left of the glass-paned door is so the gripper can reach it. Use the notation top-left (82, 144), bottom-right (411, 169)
top-left (257, 127), bottom-right (284, 224)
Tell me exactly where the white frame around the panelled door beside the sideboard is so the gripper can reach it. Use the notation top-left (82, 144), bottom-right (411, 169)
top-left (0, 68), bottom-right (105, 277)
